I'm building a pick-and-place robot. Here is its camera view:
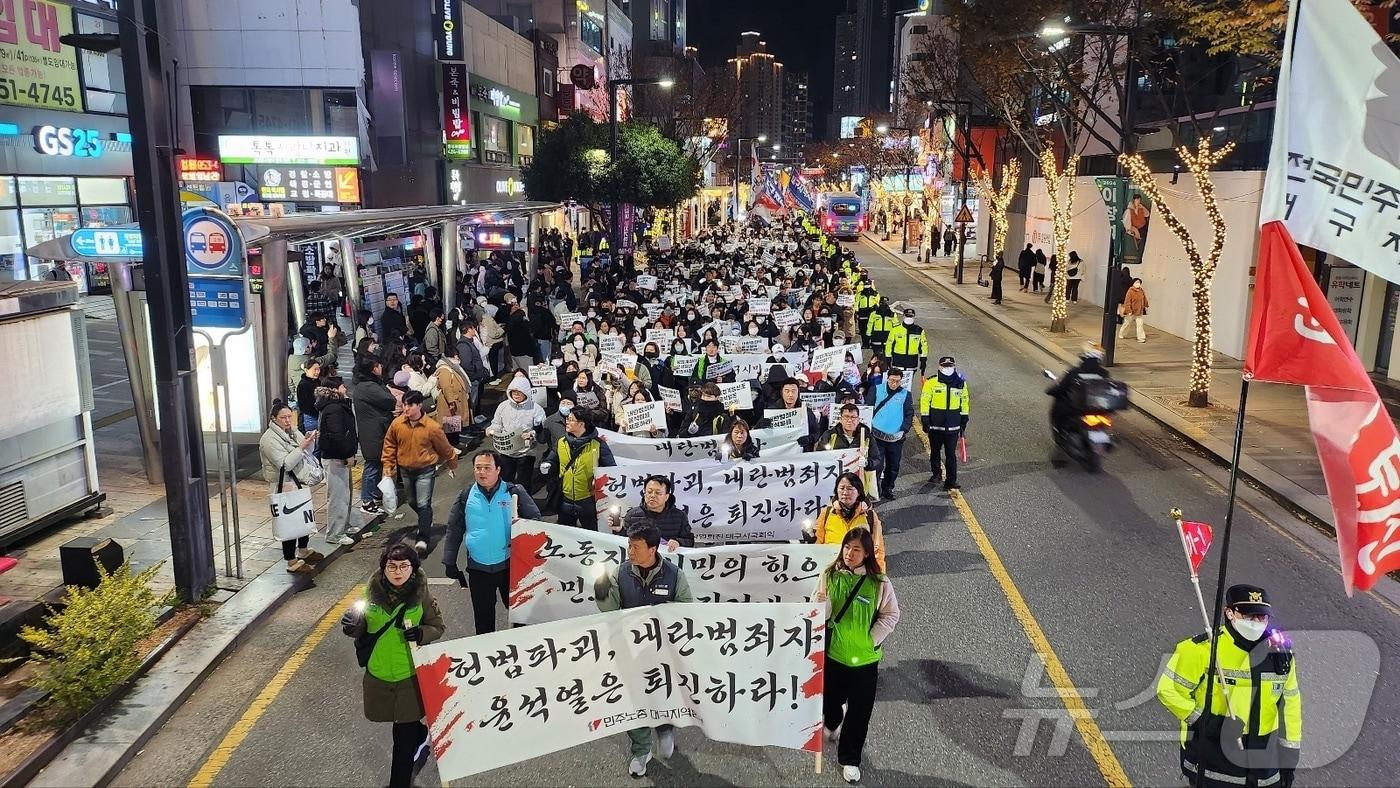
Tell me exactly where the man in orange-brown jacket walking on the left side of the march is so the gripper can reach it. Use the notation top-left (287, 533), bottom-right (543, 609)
top-left (379, 392), bottom-right (456, 556)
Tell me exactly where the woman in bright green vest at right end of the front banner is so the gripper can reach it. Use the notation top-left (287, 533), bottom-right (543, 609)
top-left (813, 528), bottom-right (899, 782)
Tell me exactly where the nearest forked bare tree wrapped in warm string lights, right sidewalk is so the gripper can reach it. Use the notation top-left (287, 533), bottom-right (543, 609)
top-left (1119, 137), bottom-right (1235, 407)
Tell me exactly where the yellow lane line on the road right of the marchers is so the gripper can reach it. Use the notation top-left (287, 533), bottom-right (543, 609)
top-left (914, 427), bottom-right (1133, 788)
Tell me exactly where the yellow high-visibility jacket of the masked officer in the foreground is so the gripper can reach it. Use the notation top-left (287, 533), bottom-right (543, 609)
top-left (1156, 627), bottom-right (1303, 750)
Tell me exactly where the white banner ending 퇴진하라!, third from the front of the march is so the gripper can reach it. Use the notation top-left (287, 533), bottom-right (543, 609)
top-left (594, 450), bottom-right (864, 543)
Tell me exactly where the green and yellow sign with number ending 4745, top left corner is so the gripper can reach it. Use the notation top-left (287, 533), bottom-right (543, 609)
top-left (0, 0), bottom-right (83, 112)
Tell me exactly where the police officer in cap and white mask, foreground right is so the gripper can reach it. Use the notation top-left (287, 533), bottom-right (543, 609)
top-left (1156, 585), bottom-right (1303, 788)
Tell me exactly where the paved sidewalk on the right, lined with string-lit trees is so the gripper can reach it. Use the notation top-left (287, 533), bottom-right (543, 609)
top-left (864, 234), bottom-right (1331, 526)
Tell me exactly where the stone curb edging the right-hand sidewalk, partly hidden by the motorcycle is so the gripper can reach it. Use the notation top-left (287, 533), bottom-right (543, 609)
top-left (862, 232), bottom-right (1336, 529)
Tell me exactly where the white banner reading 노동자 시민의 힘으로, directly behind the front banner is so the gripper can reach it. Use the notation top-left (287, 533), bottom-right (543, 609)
top-left (510, 519), bottom-right (839, 624)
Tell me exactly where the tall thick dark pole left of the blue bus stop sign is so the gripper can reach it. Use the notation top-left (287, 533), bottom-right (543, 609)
top-left (119, 0), bottom-right (214, 602)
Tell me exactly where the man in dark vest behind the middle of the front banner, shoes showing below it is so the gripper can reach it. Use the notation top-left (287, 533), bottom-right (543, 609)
top-left (594, 523), bottom-right (697, 777)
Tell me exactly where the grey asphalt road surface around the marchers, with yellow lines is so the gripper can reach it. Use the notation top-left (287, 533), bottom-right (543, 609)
top-left (116, 245), bottom-right (1400, 787)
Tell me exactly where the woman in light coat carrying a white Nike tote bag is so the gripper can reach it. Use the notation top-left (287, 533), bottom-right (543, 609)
top-left (258, 399), bottom-right (325, 574)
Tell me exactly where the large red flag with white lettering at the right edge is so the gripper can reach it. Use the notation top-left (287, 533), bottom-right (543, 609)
top-left (1245, 221), bottom-right (1400, 596)
